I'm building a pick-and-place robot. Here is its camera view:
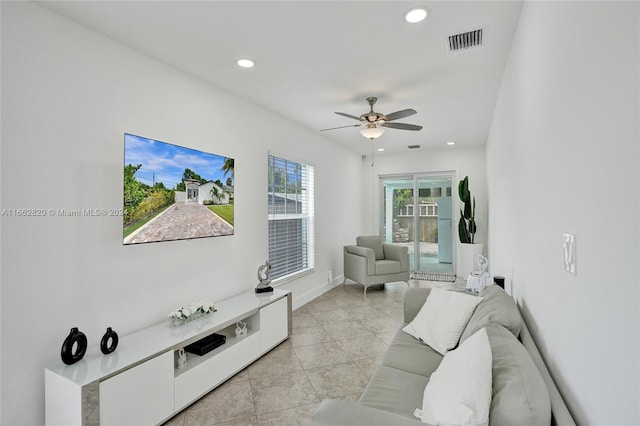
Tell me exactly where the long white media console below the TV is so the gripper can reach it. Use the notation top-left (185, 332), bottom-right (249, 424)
top-left (45, 289), bottom-right (291, 426)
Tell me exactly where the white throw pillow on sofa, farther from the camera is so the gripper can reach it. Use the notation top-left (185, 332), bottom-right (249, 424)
top-left (402, 288), bottom-right (482, 355)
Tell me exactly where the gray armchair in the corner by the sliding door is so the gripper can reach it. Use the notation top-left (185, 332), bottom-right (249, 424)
top-left (344, 235), bottom-right (409, 296)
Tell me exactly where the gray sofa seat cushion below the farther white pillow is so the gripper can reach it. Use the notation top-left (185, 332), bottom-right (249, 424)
top-left (382, 330), bottom-right (442, 377)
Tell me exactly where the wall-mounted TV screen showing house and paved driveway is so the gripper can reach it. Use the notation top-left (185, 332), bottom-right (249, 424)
top-left (123, 133), bottom-right (234, 244)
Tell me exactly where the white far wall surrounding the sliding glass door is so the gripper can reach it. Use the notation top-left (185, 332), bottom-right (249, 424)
top-left (360, 146), bottom-right (490, 275)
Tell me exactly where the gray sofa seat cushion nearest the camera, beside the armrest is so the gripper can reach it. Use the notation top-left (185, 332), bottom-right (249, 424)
top-left (359, 365), bottom-right (429, 420)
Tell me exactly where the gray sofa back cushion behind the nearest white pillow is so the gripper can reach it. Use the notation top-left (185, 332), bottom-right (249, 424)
top-left (485, 324), bottom-right (551, 426)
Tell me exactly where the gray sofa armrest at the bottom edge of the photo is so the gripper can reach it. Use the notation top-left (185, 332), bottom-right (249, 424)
top-left (311, 399), bottom-right (426, 426)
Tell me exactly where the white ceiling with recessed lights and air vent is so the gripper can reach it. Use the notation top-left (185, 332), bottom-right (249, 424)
top-left (38, 0), bottom-right (522, 154)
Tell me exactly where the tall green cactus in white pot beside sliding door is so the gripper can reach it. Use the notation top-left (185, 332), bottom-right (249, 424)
top-left (458, 176), bottom-right (483, 278)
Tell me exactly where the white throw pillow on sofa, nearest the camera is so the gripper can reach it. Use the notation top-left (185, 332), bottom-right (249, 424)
top-left (421, 328), bottom-right (492, 426)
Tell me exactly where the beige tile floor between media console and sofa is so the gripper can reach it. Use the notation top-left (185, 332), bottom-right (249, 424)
top-left (166, 280), bottom-right (458, 426)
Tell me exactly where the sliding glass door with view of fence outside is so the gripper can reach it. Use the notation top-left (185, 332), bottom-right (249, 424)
top-left (380, 173), bottom-right (455, 277)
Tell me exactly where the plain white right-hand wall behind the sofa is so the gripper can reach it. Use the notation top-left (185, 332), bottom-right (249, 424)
top-left (487, 2), bottom-right (640, 425)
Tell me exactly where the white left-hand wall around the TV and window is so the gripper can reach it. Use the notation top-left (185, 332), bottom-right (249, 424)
top-left (0, 2), bottom-right (363, 425)
